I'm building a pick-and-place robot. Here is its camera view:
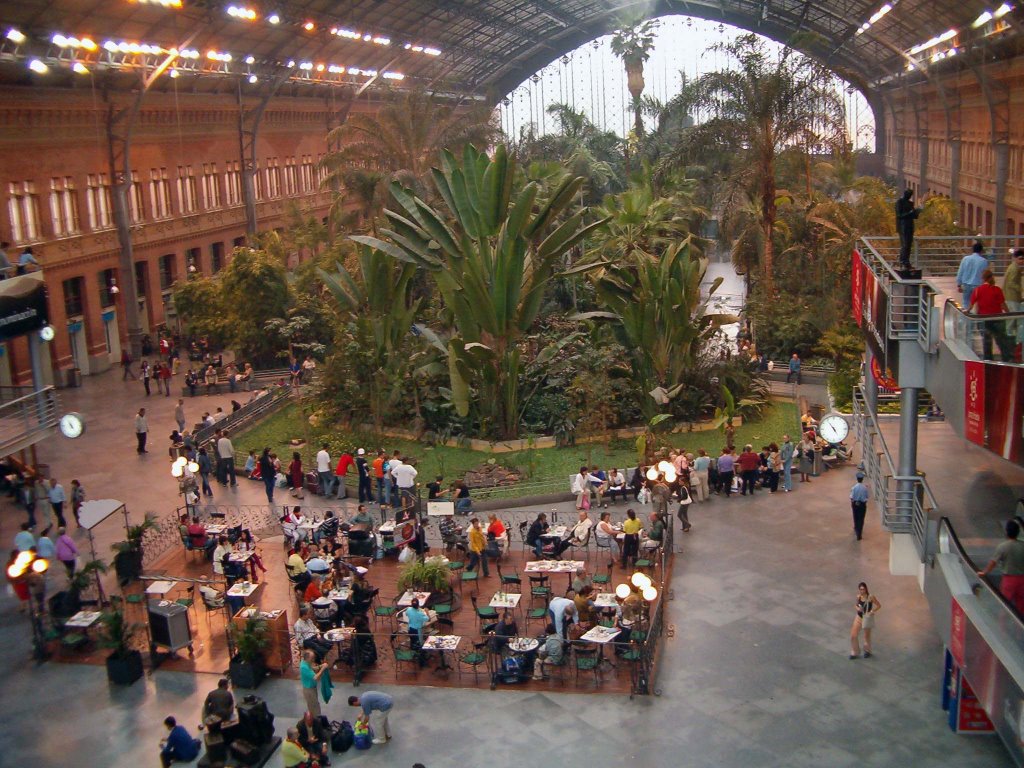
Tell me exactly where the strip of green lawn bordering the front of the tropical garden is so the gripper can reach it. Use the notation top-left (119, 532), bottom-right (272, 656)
top-left (233, 402), bottom-right (799, 497)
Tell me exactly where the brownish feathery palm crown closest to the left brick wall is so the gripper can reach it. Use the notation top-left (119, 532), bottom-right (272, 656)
top-left (322, 92), bottom-right (498, 222)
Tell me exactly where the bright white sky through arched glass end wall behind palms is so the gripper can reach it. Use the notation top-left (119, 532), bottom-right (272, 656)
top-left (500, 16), bottom-right (874, 152)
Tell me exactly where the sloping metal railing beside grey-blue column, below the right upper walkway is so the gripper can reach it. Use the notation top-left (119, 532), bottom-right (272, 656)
top-left (853, 387), bottom-right (938, 560)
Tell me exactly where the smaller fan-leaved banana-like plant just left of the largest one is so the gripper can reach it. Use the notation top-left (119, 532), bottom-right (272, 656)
top-left (316, 245), bottom-right (421, 423)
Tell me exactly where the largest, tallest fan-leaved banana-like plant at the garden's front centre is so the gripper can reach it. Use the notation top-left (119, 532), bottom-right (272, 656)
top-left (351, 144), bottom-right (606, 438)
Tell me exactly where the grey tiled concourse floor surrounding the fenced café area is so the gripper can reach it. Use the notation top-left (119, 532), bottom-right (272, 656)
top-left (0, 364), bottom-right (1010, 768)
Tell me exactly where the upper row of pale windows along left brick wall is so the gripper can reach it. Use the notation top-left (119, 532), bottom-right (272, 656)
top-left (7, 155), bottom-right (326, 243)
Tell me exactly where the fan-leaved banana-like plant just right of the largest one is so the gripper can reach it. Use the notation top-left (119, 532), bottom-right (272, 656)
top-left (575, 239), bottom-right (738, 420)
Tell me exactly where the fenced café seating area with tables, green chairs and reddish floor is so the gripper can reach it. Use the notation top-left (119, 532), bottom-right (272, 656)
top-left (59, 509), bottom-right (672, 694)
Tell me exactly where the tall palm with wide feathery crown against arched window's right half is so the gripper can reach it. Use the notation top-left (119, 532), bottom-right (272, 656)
top-left (670, 35), bottom-right (846, 294)
